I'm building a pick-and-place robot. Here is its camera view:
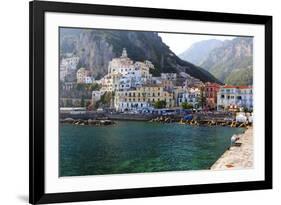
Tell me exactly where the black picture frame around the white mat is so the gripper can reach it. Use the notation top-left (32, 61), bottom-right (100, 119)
top-left (29, 1), bottom-right (272, 204)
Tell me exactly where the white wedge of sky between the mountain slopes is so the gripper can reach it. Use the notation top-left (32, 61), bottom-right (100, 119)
top-left (158, 33), bottom-right (234, 55)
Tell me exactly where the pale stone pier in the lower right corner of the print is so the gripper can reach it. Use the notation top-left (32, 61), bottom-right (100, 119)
top-left (210, 127), bottom-right (254, 170)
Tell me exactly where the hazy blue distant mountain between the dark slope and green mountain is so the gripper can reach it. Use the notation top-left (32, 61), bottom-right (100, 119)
top-left (179, 39), bottom-right (223, 65)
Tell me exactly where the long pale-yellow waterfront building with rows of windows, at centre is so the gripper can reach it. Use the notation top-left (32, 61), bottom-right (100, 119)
top-left (114, 85), bottom-right (175, 111)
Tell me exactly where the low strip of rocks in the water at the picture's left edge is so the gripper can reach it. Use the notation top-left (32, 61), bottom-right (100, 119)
top-left (60, 118), bottom-right (116, 126)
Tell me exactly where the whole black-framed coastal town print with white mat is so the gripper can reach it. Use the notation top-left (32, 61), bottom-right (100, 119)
top-left (30, 1), bottom-right (272, 204)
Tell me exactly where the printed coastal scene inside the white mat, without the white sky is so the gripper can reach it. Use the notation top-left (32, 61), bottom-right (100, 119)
top-left (58, 28), bottom-right (255, 176)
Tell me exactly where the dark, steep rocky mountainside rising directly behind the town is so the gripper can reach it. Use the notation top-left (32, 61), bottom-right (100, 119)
top-left (60, 28), bottom-right (220, 83)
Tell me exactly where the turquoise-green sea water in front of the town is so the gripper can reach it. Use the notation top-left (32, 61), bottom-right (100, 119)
top-left (59, 121), bottom-right (244, 176)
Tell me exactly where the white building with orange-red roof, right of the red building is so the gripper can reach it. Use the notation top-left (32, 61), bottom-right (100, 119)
top-left (217, 85), bottom-right (253, 110)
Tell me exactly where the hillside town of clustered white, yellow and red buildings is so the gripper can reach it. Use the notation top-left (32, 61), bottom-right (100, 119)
top-left (60, 48), bottom-right (253, 114)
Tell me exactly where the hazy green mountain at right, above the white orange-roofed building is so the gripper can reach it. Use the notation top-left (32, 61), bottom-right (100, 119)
top-left (200, 37), bottom-right (253, 85)
